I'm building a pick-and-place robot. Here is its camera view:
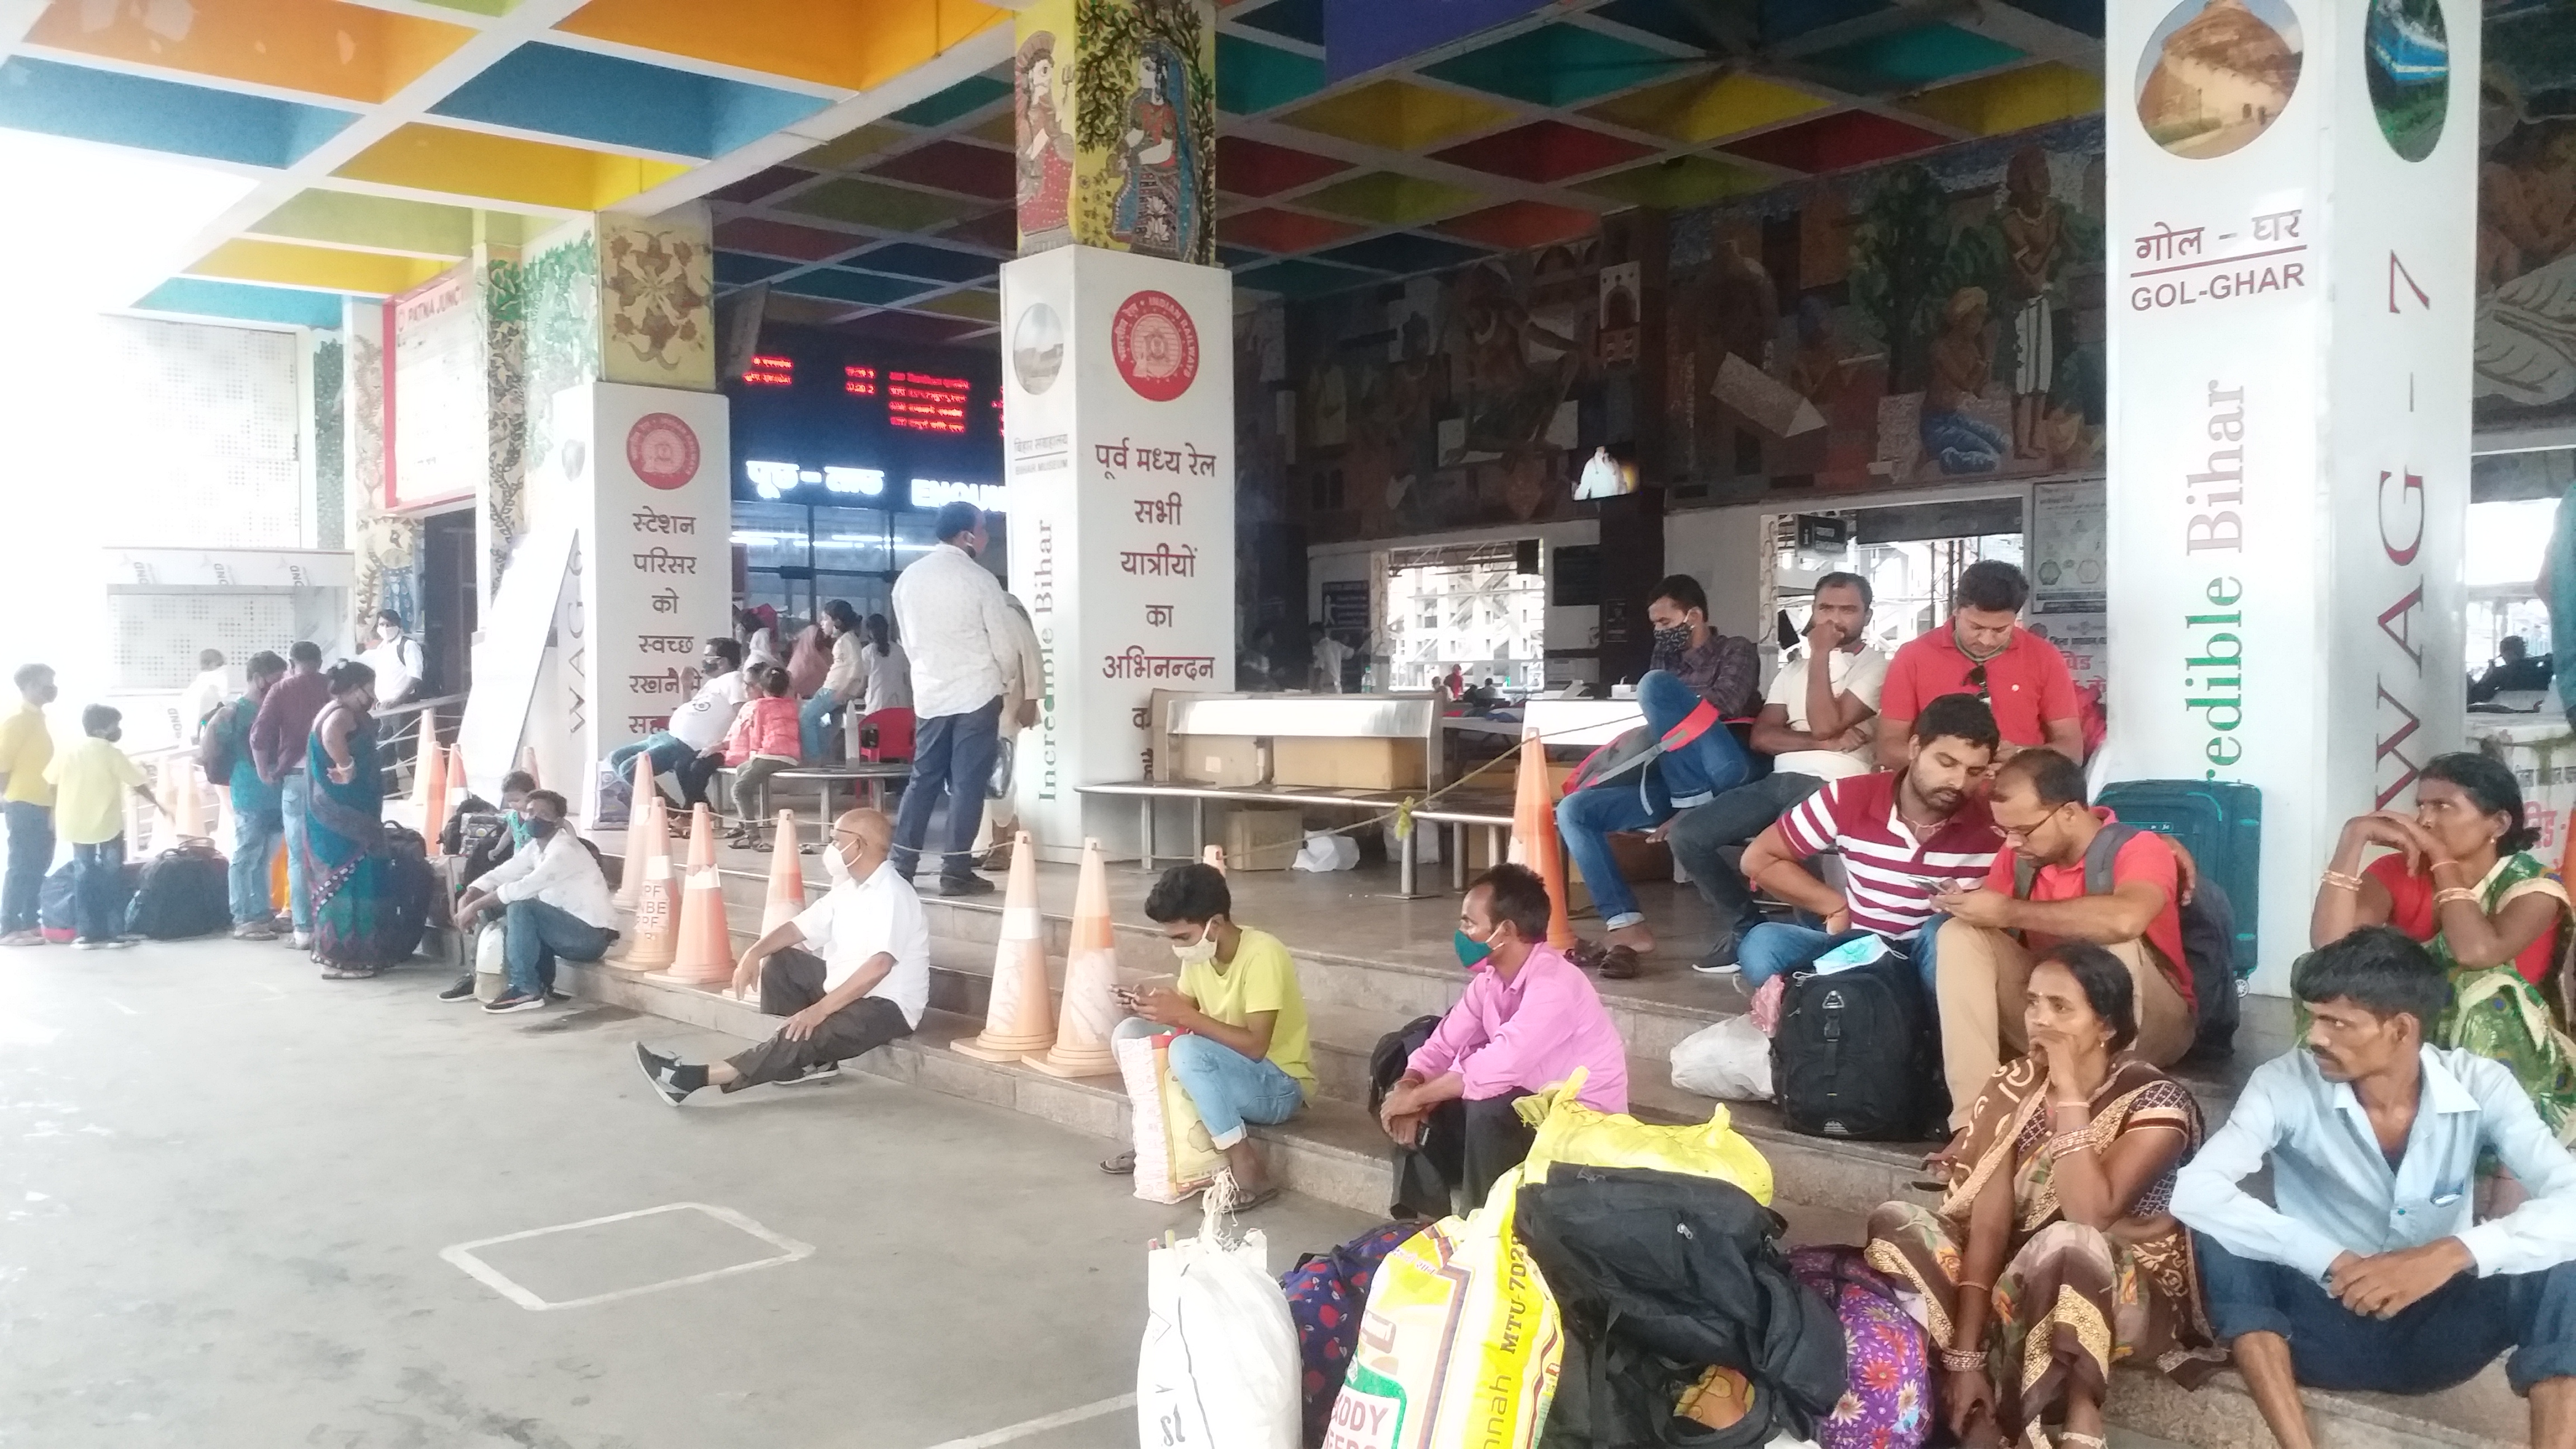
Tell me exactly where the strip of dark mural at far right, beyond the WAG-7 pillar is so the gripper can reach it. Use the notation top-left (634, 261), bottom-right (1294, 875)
top-left (2473, 0), bottom-right (2576, 428)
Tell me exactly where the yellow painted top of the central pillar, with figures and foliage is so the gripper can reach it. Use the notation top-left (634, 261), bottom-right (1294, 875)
top-left (1012, 0), bottom-right (1216, 266)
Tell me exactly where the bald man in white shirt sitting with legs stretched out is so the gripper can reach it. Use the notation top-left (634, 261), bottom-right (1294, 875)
top-left (636, 809), bottom-right (930, 1106)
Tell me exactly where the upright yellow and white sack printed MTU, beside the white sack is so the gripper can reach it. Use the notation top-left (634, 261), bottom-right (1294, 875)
top-left (1324, 1168), bottom-right (1566, 1449)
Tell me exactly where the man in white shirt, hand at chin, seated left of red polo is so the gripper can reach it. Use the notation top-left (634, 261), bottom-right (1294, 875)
top-left (1664, 572), bottom-right (1888, 974)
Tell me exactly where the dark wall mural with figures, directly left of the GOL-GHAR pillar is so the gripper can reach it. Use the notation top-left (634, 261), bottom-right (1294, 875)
top-left (1666, 121), bottom-right (2105, 503)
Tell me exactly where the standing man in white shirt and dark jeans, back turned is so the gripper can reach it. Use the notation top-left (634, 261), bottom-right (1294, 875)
top-left (894, 503), bottom-right (1038, 894)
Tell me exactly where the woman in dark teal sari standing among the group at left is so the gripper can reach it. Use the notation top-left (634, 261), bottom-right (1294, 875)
top-left (304, 662), bottom-right (399, 980)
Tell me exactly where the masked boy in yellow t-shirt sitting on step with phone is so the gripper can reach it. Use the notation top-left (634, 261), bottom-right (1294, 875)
top-left (1102, 866), bottom-right (1314, 1209)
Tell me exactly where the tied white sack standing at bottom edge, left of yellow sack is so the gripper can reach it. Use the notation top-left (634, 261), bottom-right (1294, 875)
top-left (1136, 1178), bottom-right (1304, 1449)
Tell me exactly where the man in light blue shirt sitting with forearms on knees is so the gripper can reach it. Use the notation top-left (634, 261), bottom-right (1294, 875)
top-left (2174, 923), bottom-right (2576, 1449)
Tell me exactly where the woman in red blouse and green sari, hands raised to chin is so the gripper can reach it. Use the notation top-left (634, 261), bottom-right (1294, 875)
top-left (2308, 753), bottom-right (2576, 1142)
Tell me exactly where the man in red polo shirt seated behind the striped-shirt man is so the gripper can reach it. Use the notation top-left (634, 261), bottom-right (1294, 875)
top-left (1878, 560), bottom-right (2084, 771)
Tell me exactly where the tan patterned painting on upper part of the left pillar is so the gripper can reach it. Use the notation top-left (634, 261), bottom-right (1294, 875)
top-left (598, 206), bottom-right (716, 392)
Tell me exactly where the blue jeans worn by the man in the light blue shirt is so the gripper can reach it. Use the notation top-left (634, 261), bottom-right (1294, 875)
top-left (2192, 1233), bottom-right (2576, 1395)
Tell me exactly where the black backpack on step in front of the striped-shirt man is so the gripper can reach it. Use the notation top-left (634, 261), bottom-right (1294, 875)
top-left (1772, 954), bottom-right (1950, 1142)
